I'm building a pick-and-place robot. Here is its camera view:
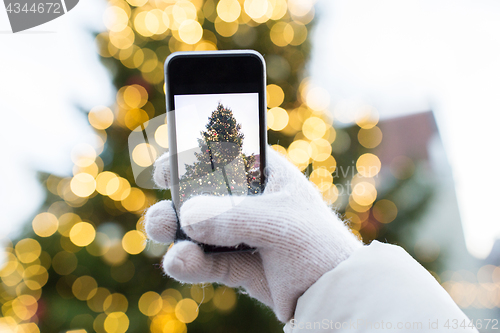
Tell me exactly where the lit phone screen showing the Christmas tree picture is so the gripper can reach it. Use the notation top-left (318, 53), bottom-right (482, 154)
top-left (174, 93), bottom-right (261, 204)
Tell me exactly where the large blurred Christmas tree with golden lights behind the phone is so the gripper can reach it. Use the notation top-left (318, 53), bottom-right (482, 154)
top-left (0, 0), bottom-right (436, 333)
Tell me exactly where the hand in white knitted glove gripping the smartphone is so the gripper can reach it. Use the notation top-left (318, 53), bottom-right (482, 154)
top-left (145, 148), bottom-right (362, 322)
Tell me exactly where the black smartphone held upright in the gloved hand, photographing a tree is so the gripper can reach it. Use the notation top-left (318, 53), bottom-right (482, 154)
top-left (165, 50), bottom-right (267, 252)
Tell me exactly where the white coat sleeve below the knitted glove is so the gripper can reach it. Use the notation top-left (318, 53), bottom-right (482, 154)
top-left (284, 241), bottom-right (477, 333)
